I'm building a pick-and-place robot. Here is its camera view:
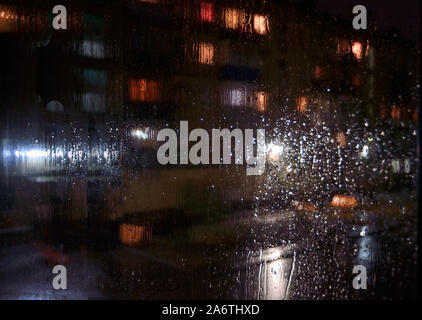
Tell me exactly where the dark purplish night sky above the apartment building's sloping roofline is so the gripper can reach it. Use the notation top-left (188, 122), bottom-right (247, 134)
top-left (291, 0), bottom-right (420, 41)
